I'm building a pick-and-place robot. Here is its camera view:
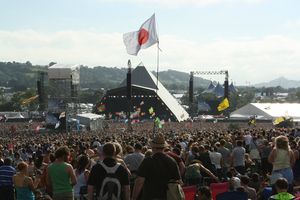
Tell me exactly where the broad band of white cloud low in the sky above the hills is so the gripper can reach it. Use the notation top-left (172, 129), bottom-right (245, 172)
top-left (0, 30), bottom-right (300, 84)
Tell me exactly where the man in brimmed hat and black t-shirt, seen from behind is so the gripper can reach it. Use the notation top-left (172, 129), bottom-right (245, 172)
top-left (132, 134), bottom-right (181, 200)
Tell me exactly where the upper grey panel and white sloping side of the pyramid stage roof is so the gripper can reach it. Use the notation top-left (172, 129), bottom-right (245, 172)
top-left (121, 63), bottom-right (189, 121)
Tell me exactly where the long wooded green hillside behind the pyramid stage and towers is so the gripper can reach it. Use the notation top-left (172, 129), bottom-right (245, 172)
top-left (0, 62), bottom-right (210, 90)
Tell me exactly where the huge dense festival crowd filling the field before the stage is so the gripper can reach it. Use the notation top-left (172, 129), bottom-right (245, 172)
top-left (0, 121), bottom-right (300, 200)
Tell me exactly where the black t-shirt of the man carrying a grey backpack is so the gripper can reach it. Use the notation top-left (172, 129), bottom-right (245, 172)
top-left (88, 158), bottom-right (129, 196)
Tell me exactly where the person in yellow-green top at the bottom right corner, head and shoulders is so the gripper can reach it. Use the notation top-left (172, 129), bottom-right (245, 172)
top-left (270, 178), bottom-right (295, 200)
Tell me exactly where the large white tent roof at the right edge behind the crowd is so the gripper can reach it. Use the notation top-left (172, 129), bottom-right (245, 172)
top-left (230, 103), bottom-right (300, 120)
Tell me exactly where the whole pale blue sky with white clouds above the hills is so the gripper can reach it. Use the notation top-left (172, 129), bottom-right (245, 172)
top-left (0, 0), bottom-right (300, 85)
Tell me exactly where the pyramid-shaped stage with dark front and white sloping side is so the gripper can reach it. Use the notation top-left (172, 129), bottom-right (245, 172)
top-left (96, 64), bottom-right (189, 121)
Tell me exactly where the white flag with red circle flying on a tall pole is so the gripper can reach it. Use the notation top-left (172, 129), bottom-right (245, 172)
top-left (123, 14), bottom-right (158, 56)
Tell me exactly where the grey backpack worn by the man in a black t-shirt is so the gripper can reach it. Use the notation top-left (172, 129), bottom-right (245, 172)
top-left (98, 162), bottom-right (121, 200)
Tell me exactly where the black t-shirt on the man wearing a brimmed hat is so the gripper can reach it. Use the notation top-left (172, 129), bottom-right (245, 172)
top-left (137, 153), bottom-right (180, 200)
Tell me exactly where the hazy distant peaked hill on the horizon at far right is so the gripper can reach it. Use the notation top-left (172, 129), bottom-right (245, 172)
top-left (254, 77), bottom-right (300, 89)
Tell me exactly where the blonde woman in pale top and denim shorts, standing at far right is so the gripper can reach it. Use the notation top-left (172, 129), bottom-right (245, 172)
top-left (268, 135), bottom-right (295, 188)
